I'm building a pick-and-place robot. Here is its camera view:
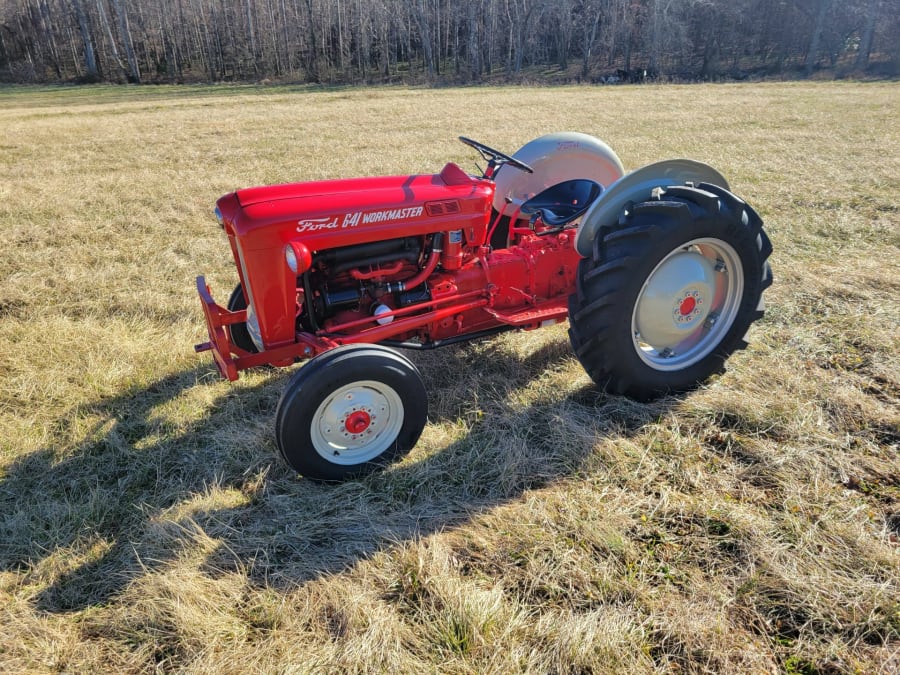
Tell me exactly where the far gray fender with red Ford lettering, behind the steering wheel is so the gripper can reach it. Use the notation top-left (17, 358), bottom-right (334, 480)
top-left (494, 131), bottom-right (625, 212)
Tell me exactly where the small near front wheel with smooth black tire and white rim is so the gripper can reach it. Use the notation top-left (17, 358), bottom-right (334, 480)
top-left (275, 344), bottom-right (428, 482)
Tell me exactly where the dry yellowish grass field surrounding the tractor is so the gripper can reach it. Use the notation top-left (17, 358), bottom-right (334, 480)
top-left (0, 83), bottom-right (900, 674)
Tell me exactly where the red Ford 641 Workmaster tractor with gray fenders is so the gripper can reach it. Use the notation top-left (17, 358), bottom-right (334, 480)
top-left (196, 133), bottom-right (772, 481)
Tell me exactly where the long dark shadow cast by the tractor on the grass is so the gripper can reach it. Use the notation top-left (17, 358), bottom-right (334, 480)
top-left (0, 332), bottom-right (667, 612)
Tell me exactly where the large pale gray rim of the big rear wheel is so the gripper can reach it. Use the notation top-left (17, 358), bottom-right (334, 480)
top-left (631, 238), bottom-right (744, 371)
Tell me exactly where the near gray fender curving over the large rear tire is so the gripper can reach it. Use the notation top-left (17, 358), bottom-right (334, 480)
top-left (575, 159), bottom-right (728, 258)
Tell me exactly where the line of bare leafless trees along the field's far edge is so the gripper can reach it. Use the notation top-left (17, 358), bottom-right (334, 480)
top-left (0, 0), bottom-right (900, 84)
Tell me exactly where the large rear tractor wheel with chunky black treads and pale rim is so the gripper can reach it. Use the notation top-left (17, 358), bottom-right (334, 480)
top-left (569, 183), bottom-right (772, 401)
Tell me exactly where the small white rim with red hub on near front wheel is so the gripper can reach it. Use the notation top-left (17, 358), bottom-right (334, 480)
top-left (310, 380), bottom-right (403, 466)
